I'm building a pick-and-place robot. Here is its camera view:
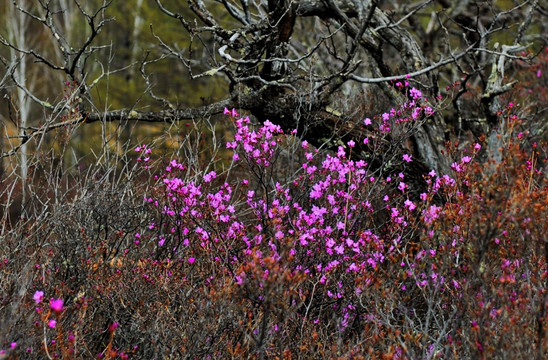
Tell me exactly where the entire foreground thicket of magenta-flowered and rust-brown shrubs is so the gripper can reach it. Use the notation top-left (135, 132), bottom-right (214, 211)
top-left (0, 84), bottom-right (548, 359)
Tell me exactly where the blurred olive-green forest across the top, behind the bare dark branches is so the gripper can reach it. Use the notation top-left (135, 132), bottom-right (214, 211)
top-left (0, 0), bottom-right (546, 181)
